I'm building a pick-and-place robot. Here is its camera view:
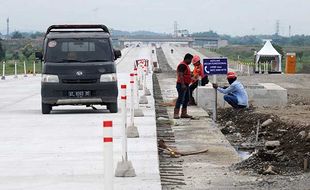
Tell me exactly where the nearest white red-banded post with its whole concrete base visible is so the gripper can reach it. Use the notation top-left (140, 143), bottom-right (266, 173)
top-left (115, 85), bottom-right (136, 177)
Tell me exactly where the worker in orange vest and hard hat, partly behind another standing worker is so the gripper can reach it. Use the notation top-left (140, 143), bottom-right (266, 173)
top-left (189, 55), bottom-right (209, 105)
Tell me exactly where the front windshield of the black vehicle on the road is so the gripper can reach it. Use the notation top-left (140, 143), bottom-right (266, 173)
top-left (45, 38), bottom-right (113, 63)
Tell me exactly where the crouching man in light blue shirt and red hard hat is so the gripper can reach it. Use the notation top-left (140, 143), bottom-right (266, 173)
top-left (213, 72), bottom-right (248, 109)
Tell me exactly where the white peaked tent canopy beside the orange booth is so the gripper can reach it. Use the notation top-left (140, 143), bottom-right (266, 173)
top-left (255, 40), bottom-right (282, 72)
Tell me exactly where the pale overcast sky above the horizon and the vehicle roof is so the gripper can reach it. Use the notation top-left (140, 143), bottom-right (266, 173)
top-left (0, 0), bottom-right (310, 35)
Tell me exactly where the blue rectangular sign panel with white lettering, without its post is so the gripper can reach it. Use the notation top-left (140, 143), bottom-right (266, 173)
top-left (203, 58), bottom-right (228, 75)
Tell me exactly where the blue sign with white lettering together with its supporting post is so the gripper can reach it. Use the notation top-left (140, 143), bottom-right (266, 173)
top-left (203, 58), bottom-right (228, 122)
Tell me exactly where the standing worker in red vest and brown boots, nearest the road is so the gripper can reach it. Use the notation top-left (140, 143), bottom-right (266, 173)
top-left (173, 53), bottom-right (193, 119)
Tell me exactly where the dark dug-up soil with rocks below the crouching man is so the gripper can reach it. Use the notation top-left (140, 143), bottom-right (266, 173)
top-left (219, 108), bottom-right (310, 175)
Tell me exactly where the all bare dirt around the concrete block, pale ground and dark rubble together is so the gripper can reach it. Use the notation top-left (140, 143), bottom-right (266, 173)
top-left (219, 74), bottom-right (310, 180)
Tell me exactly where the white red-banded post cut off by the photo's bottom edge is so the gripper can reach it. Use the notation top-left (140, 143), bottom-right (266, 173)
top-left (103, 121), bottom-right (113, 190)
